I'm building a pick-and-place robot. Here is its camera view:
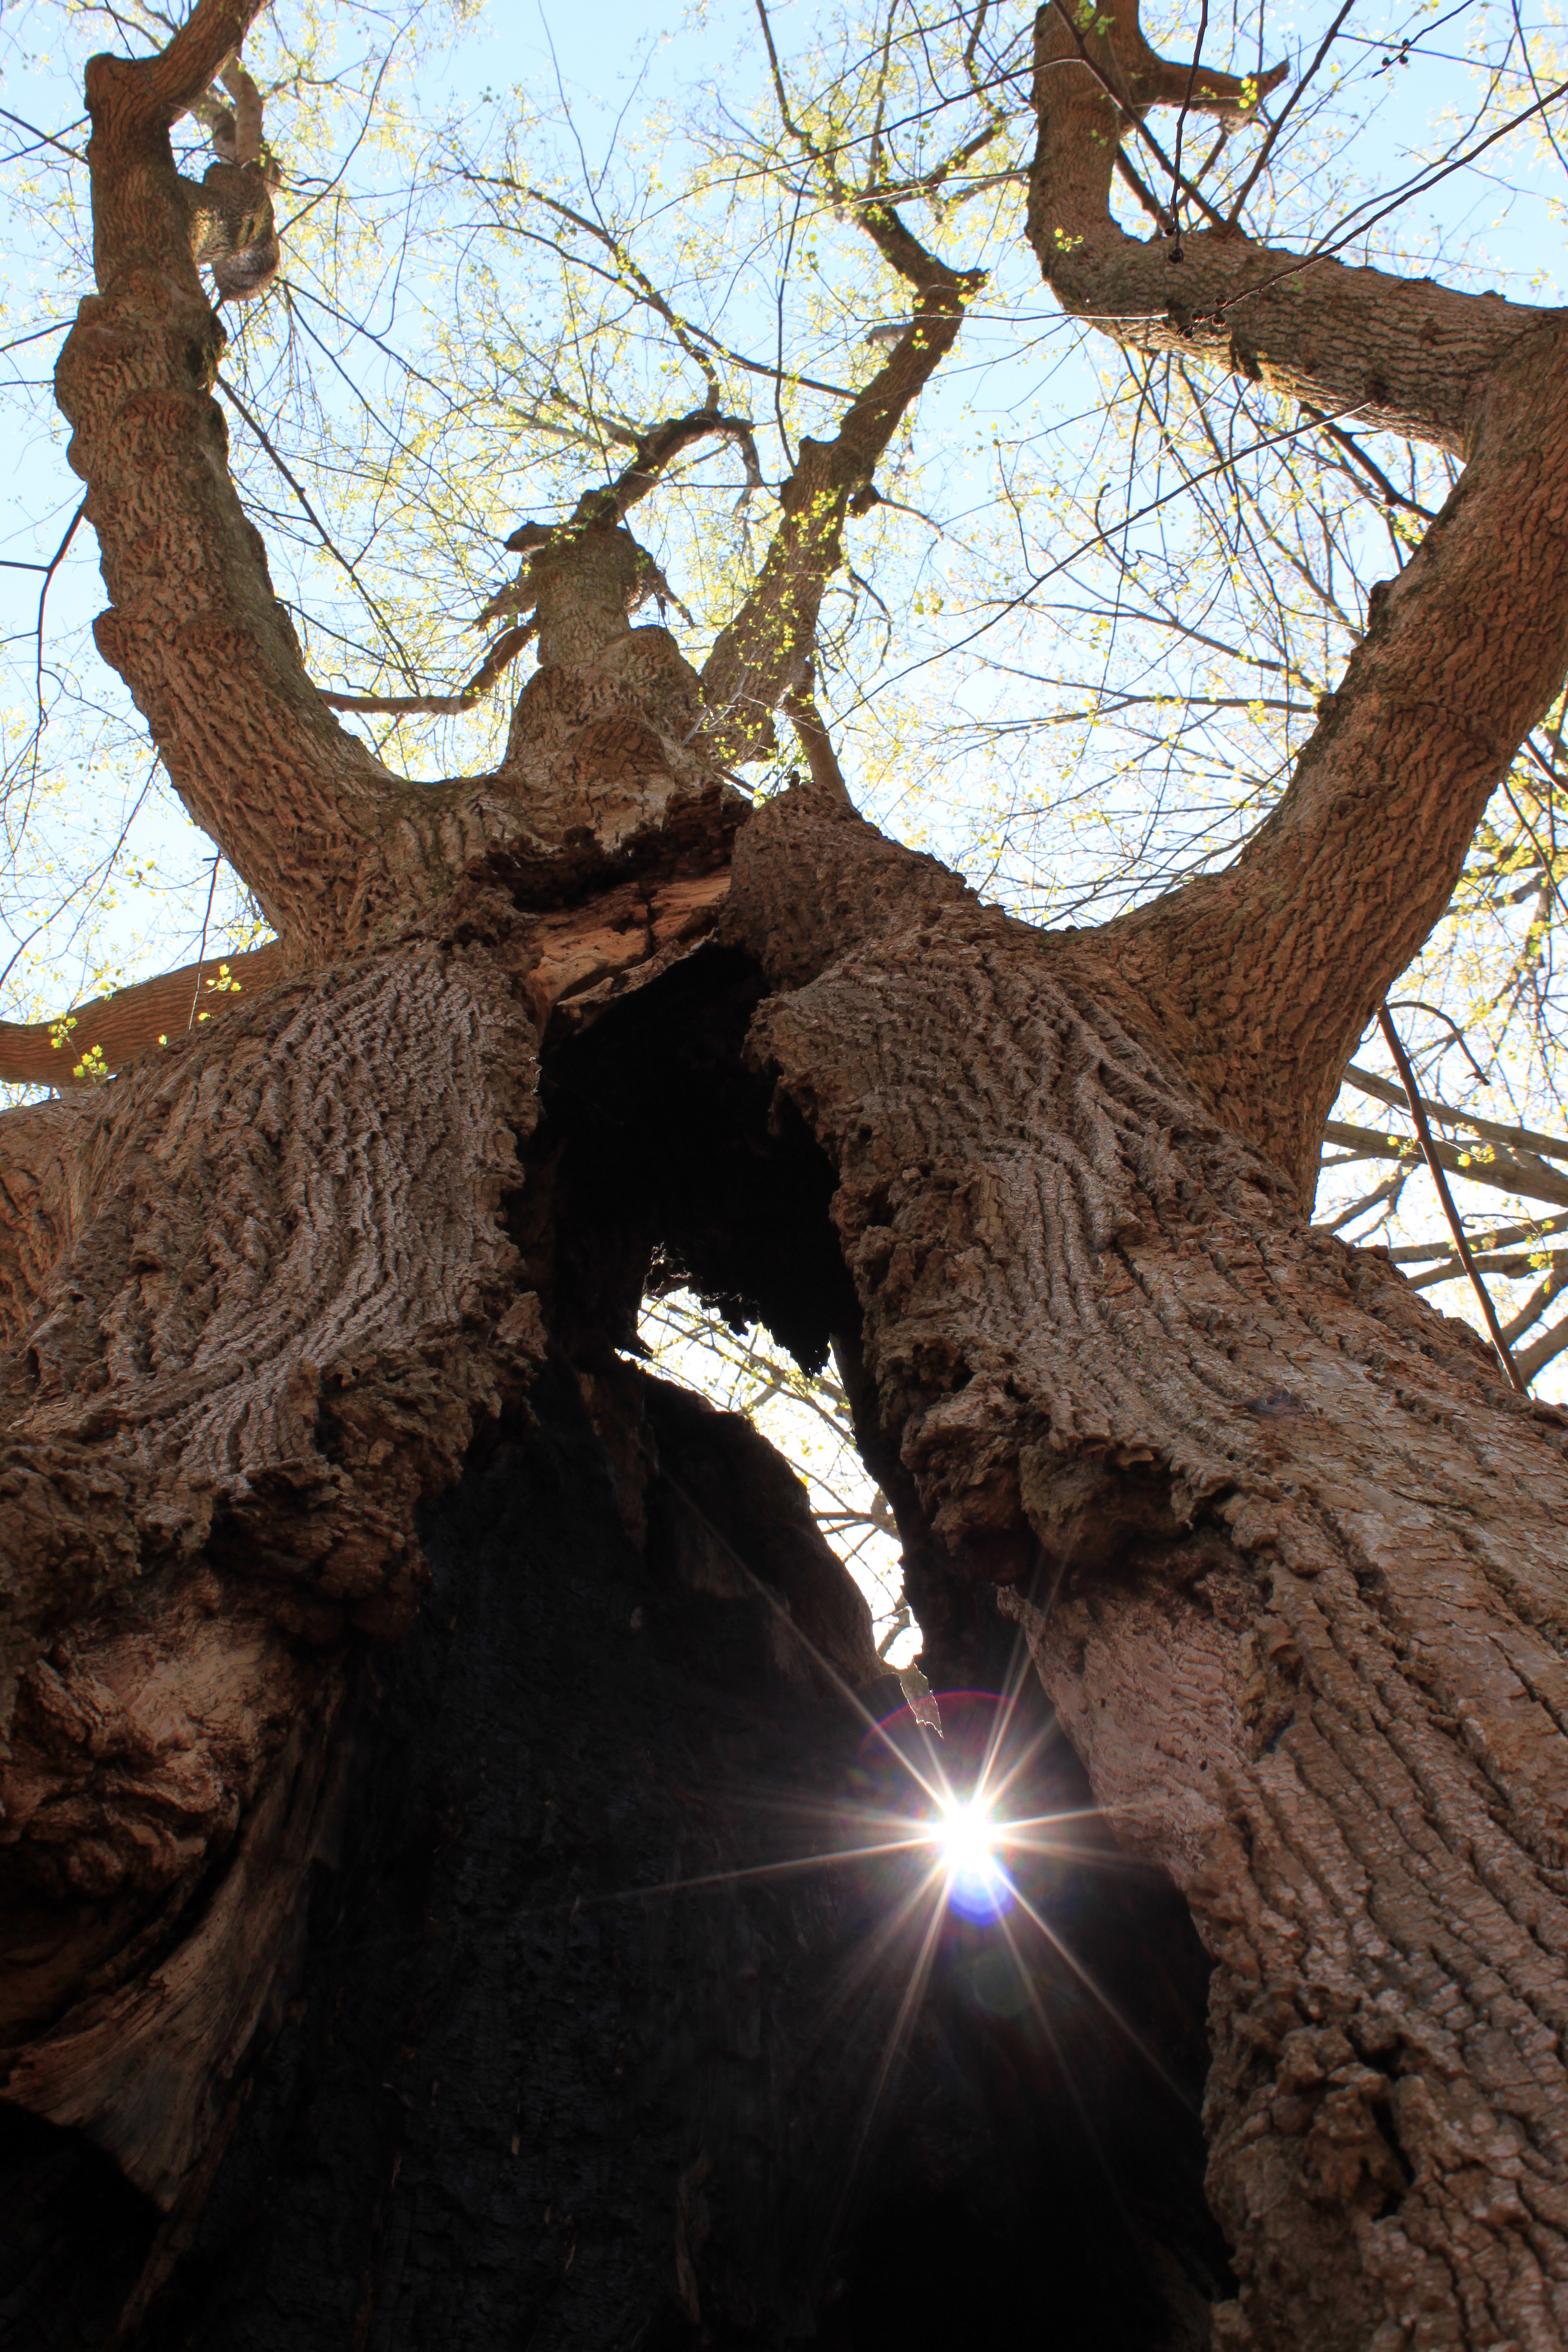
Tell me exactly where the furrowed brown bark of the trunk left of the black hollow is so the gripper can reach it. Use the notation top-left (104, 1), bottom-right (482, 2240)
top-left (0, 877), bottom-right (742, 2202)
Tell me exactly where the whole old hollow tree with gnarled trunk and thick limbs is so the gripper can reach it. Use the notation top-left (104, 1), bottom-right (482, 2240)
top-left (0, 0), bottom-right (1568, 2352)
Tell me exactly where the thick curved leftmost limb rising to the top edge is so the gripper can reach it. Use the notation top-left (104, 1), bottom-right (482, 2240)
top-left (56, 16), bottom-right (423, 945)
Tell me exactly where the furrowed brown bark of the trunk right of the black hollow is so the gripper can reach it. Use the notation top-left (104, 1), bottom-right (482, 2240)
top-left (727, 795), bottom-right (1568, 2352)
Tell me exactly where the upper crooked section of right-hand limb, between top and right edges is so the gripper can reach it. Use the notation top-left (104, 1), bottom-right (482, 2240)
top-left (1029, 0), bottom-right (1540, 451)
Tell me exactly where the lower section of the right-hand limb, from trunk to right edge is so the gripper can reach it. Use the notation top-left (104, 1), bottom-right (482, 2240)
top-left (1110, 320), bottom-right (1568, 1197)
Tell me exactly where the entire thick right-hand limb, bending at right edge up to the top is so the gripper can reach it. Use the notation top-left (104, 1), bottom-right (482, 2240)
top-left (1029, 0), bottom-right (1568, 1197)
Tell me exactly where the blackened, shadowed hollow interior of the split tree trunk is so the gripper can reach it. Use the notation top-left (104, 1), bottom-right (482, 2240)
top-left (0, 955), bottom-right (1232, 2352)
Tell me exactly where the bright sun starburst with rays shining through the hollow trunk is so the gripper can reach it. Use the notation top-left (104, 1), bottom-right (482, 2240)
top-left (566, 1599), bottom-right (1192, 2234)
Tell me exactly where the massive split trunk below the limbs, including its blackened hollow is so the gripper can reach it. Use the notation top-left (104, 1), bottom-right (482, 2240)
top-left (7, 790), bottom-right (1568, 2352)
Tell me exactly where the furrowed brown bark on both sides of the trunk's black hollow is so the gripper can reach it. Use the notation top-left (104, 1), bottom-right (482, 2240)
top-left (4, 790), bottom-right (1568, 2352)
